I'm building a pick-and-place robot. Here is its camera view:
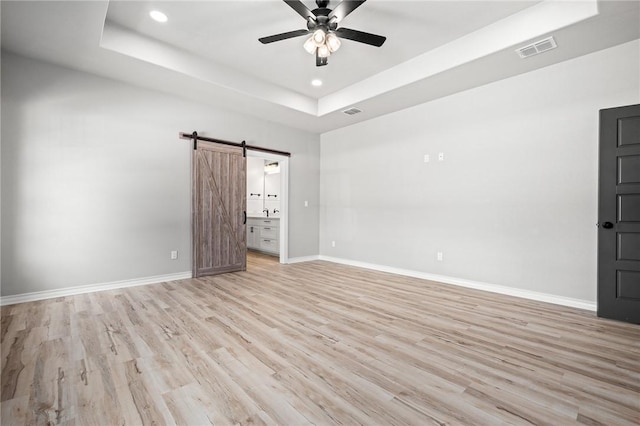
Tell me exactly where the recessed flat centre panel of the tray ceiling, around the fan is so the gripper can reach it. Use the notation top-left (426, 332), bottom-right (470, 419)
top-left (102, 0), bottom-right (535, 99)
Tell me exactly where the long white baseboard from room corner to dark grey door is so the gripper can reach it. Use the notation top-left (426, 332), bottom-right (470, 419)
top-left (317, 255), bottom-right (597, 312)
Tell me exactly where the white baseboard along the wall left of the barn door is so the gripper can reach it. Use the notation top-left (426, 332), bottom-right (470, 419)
top-left (0, 271), bottom-right (191, 306)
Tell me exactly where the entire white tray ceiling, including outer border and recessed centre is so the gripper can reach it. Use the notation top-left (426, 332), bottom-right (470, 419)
top-left (1, 0), bottom-right (640, 133)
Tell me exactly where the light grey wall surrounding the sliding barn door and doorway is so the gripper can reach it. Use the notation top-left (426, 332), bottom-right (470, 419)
top-left (1, 52), bottom-right (319, 296)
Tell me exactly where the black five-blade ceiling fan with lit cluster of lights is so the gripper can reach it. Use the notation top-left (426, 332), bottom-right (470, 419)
top-left (258, 0), bottom-right (387, 67)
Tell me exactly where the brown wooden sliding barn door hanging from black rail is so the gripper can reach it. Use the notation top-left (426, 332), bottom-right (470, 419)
top-left (192, 141), bottom-right (247, 277)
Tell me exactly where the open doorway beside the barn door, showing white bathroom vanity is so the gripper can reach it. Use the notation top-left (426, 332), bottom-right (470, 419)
top-left (246, 150), bottom-right (289, 263)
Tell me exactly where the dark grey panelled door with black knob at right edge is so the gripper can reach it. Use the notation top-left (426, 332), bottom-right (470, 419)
top-left (598, 105), bottom-right (640, 324)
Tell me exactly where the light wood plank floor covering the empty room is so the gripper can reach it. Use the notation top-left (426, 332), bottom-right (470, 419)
top-left (0, 254), bottom-right (640, 425)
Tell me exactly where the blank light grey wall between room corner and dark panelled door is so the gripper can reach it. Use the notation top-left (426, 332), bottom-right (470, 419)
top-left (320, 41), bottom-right (640, 302)
